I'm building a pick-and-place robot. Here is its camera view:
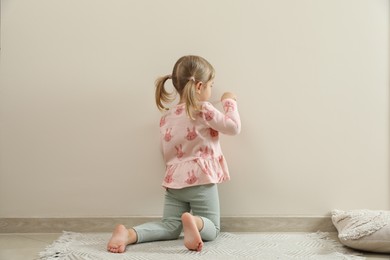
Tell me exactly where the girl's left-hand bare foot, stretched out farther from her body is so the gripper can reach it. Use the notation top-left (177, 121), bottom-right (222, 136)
top-left (107, 225), bottom-right (137, 253)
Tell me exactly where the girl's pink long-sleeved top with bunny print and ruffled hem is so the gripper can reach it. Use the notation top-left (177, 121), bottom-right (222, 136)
top-left (160, 99), bottom-right (241, 189)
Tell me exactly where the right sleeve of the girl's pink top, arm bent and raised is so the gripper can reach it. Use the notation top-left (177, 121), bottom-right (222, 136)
top-left (201, 99), bottom-right (241, 135)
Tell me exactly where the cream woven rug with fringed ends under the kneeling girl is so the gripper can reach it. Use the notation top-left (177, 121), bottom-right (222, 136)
top-left (39, 232), bottom-right (365, 260)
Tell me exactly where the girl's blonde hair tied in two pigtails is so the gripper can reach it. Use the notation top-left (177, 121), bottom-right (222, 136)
top-left (156, 55), bottom-right (215, 119)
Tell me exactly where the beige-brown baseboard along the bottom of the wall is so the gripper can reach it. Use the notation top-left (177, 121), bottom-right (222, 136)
top-left (0, 216), bottom-right (336, 233)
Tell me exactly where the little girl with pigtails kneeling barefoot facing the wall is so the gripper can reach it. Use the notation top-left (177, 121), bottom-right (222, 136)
top-left (107, 56), bottom-right (241, 253)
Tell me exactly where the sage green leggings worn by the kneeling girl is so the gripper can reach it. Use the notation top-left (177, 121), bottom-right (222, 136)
top-left (133, 184), bottom-right (220, 243)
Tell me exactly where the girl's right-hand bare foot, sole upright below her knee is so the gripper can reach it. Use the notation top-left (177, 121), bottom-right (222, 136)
top-left (181, 212), bottom-right (203, 252)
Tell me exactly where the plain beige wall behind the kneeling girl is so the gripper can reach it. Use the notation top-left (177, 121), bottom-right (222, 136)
top-left (0, 0), bottom-right (390, 217)
